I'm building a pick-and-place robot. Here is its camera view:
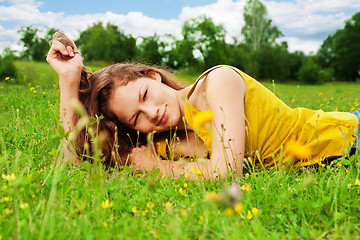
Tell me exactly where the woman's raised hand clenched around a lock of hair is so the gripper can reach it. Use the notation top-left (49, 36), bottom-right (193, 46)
top-left (46, 35), bottom-right (83, 83)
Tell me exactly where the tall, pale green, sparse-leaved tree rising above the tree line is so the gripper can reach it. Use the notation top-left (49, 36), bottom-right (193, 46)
top-left (241, 0), bottom-right (282, 51)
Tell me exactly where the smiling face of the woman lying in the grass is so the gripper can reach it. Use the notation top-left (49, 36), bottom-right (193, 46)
top-left (109, 73), bottom-right (182, 133)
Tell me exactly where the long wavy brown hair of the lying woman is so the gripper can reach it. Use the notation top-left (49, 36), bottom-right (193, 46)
top-left (75, 63), bottom-right (184, 166)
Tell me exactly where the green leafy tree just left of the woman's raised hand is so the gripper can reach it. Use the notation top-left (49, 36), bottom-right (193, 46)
top-left (19, 26), bottom-right (57, 61)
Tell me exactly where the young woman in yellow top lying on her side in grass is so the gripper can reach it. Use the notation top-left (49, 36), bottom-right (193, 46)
top-left (47, 31), bottom-right (360, 179)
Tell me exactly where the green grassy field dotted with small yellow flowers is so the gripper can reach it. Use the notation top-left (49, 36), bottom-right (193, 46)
top-left (0, 62), bottom-right (360, 239)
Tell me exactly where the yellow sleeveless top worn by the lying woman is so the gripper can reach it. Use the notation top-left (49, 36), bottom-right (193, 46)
top-left (157, 65), bottom-right (359, 166)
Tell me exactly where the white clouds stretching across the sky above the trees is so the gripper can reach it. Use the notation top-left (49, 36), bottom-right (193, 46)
top-left (0, 0), bottom-right (360, 53)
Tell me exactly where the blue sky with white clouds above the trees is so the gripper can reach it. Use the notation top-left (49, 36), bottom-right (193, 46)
top-left (0, 0), bottom-right (360, 53)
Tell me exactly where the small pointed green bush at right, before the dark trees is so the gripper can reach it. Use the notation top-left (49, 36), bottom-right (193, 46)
top-left (297, 58), bottom-right (323, 84)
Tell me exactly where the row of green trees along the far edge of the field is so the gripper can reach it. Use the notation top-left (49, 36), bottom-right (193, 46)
top-left (0, 0), bottom-right (360, 84)
